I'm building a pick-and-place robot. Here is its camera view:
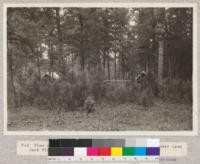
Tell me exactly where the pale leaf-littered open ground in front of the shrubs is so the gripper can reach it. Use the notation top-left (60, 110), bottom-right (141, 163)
top-left (8, 100), bottom-right (192, 131)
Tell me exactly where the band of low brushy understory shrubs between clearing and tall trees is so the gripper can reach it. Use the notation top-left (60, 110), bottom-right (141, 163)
top-left (8, 65), bottom-right (192, 111)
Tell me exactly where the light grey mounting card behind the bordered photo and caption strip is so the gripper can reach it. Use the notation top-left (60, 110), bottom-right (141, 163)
top-left (0, 0), bottom-right (200, 164)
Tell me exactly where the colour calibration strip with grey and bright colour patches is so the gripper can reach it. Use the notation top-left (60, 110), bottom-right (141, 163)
top-left (48, 139), bottom-right (160, 157)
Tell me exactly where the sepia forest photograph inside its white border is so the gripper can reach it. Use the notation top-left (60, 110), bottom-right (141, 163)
top-left (7, 7), bottom-right (193, 131)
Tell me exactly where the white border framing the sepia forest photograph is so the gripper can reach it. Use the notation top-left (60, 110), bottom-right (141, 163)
top-left (3, 2), bottom-right (198, 137)
